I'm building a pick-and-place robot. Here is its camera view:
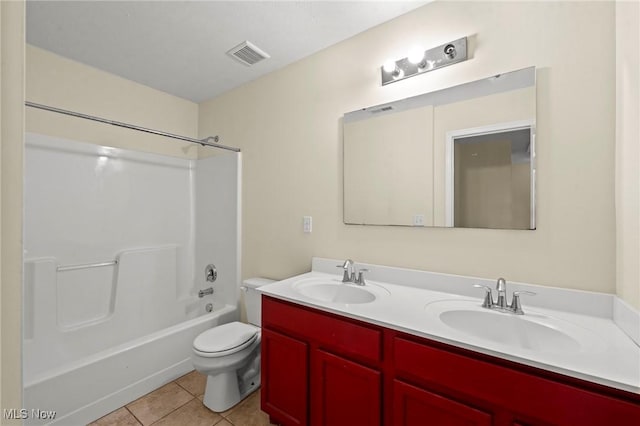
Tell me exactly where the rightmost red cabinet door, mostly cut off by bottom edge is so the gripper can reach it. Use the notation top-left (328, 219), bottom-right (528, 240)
top-left (393, 380), bottom-right (493, 426)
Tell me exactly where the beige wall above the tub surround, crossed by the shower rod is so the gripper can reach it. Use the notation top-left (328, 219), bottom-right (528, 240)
top-left (26, 45), bottom-right (198, 158)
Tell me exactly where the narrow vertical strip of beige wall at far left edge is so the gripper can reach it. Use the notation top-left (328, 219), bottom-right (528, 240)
top-left (0, 1), bottom-right (25, 424)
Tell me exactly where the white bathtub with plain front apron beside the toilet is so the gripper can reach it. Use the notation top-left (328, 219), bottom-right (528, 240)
top-left (23, 305), bottom-right (238, 426)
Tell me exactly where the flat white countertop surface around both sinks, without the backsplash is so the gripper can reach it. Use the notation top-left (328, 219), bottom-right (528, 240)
top-left (258, 259), bottom-right (640, 394)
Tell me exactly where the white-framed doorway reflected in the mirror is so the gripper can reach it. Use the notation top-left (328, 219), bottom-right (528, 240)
top-left (447, 123), bottom-right (535, 229)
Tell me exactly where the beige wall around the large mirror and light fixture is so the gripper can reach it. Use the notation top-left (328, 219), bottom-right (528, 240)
top-left (199, 2), bottom-right (615, 292)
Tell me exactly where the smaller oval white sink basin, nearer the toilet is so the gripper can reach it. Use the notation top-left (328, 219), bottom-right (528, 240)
top-left (292, 278), bottom-right (384, 304)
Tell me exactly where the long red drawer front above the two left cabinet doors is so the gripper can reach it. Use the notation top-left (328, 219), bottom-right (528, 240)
top-left (262, 296), bottom-right (382, 362)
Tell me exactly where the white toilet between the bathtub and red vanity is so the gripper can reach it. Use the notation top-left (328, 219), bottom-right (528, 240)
top-left (191, 278), bottom-right (273, 412)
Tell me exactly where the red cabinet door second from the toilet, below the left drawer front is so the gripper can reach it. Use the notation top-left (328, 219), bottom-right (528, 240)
top-left (311, 350), bottom-right (382, 426)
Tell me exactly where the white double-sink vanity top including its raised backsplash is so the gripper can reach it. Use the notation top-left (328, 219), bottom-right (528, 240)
top-left (259, 258), bottom-right (640, 393)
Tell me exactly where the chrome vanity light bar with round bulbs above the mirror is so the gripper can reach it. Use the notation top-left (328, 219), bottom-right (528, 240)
top-left (380, 37), bottom-right (468, 86)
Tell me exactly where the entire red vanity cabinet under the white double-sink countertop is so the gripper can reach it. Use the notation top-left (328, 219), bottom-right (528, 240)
top-left (262, 296), bottom-right (640, 426)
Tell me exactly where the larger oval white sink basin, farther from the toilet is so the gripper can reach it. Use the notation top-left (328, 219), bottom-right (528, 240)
top-left (425, 300), bottom-right (601, 353)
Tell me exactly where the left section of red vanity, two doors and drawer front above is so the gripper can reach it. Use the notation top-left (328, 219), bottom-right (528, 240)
top-left (261, 296), bottom-right (382, 426)
